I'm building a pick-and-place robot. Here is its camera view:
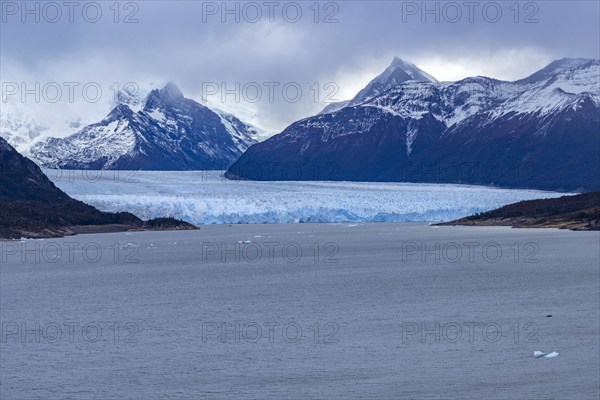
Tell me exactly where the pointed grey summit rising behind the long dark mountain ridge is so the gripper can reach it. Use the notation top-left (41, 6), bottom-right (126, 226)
top-left (349, 57), bottom-right (437, 106)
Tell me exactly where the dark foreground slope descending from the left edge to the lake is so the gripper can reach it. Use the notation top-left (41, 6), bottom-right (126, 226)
top-left (0, 138), bottom-right (195, 239)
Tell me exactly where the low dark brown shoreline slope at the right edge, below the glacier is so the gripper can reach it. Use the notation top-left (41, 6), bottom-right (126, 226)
top-left (440, 192), bottom-right (600, 230)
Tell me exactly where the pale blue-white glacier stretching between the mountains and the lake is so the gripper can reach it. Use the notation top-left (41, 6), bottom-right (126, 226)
top-left (44, 169), bottom-right (563, 225)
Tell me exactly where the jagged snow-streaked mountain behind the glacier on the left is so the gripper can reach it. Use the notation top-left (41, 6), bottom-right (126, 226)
top-left (30, 83), bottom-right (261, 170)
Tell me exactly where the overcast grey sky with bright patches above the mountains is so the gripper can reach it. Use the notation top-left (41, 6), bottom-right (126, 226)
top-left (0, 0), bottom-right (600, 134)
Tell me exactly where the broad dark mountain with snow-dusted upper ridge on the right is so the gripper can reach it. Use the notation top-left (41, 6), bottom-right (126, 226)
top-left (226, 60), bottom-right (600, 191)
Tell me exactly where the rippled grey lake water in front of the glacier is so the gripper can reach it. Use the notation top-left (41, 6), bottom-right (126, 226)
top-left (0, 224), bottom-right (600, 400)
